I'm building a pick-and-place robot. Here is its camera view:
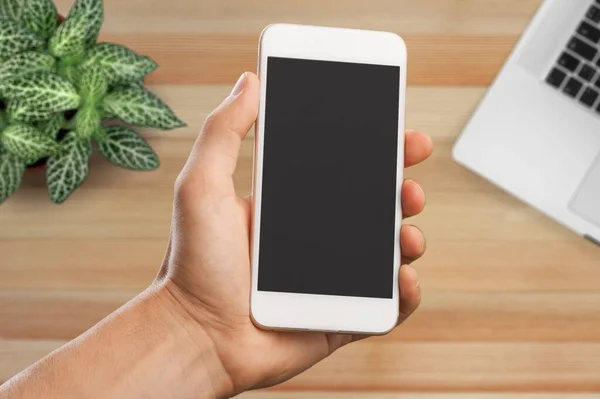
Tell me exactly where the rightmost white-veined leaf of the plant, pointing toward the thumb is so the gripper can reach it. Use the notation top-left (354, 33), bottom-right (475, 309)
top-left (104, 86), bottom-right (185, 130)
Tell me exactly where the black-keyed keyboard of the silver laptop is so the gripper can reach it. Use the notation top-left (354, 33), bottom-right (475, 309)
top-left (546, 0), bottom-right (600, 110)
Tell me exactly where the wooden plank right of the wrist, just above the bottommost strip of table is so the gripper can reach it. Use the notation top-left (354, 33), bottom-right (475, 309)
top-left (278, 340), bottom-right (600, 392)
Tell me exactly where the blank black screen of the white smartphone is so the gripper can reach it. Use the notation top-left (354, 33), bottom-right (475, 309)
top-left (258, 57), bottom-right (400, 298)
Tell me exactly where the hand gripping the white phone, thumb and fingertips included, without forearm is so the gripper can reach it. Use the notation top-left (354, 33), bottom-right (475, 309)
top-left (157, 73), bottom-right (432, 396)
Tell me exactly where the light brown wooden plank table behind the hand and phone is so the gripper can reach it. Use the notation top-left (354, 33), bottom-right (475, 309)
top-left (0, 0), bottom-right (600, 399)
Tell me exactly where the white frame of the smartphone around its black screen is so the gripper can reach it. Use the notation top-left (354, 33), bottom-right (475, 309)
top-left (250, 24), bottom-right (407, 334)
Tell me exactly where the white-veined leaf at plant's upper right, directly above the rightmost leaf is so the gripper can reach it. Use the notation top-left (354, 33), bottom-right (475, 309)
top-left (83, 43), bottom-right (158, 86)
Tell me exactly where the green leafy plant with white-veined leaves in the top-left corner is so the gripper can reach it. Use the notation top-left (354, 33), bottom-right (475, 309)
top-left (0, 0), bottom-right (185, 203)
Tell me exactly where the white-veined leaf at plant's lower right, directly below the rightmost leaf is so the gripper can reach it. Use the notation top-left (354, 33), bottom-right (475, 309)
top-left (96, 126), bottom-right (160, 170)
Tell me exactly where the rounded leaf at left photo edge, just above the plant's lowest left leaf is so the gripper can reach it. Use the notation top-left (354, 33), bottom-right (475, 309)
top-left (1, 124), bottom-right (58, 161)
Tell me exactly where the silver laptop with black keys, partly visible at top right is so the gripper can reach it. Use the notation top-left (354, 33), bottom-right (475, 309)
top-left (453, 0), bottom-right (600, 245)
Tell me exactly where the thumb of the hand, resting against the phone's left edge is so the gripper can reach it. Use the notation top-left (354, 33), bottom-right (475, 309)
top-left (186, 72), bottom-right (260, 188)
